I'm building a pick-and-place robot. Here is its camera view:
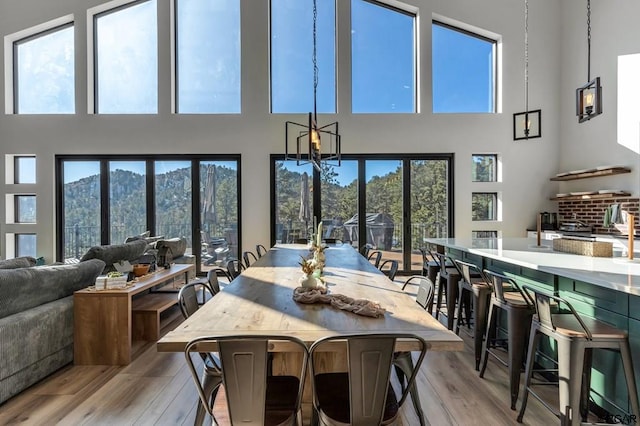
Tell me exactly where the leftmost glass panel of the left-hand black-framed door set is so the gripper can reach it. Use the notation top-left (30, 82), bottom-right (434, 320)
top-left (62, 161), bottom-right (101, 260)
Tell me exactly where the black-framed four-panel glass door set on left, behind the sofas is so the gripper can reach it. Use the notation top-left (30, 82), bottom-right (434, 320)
top-left (56, 155), bottom-right (241, 271)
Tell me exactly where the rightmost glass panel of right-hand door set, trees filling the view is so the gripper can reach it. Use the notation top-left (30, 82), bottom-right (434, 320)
top-left (410, 160), bottom-right (449, 271)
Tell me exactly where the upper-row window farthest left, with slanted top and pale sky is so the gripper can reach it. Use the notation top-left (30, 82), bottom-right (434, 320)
top-left (13, 23), bottom-right (75, 114)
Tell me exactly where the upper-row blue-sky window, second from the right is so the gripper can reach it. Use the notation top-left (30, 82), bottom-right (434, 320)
top-left (351, 0), bottom-right (416, 113)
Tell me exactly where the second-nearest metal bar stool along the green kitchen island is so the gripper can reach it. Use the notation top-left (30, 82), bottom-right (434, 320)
top-left (480, 269), bottom-right (535, 410)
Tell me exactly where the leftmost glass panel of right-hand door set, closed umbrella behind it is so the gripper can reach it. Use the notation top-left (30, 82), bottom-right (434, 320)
top-left (275, 161), bottom-right (314, 243)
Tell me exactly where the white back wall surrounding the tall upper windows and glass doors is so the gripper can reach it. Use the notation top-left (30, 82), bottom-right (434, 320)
top-left (0, 0), bottom-right (564, 260)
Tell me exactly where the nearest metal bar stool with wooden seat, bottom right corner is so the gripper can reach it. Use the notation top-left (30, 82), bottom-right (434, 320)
top-left (518, 286), bottom-right (640, 425)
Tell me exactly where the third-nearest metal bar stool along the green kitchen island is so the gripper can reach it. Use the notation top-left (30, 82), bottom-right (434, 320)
top-left (455, 259), bottom-right (491, 370)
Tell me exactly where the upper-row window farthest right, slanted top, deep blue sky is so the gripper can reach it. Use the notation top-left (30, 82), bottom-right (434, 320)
top-left (432, 21), bottom-right (496, 113)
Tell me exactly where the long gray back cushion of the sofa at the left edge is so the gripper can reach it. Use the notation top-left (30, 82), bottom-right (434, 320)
top-left (0, 259), bottom-right (104, 318)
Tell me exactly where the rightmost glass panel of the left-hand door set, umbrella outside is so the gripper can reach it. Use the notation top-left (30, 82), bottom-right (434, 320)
top-left (200, 161), bottom-right (239, 270)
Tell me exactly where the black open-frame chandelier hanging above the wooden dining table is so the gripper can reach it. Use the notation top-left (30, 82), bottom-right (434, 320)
top-left (285, 0), bottom-right (341, 172)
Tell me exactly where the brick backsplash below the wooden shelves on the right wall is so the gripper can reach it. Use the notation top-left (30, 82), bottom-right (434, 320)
top-left (558, 197), bottom-right (640, 235)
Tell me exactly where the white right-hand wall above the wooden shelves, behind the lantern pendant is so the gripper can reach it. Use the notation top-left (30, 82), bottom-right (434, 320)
top-left (559, 0), bottom-right (640, 197)
